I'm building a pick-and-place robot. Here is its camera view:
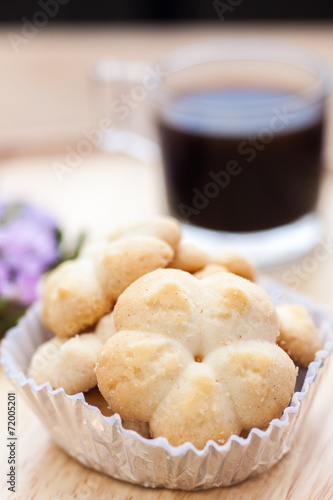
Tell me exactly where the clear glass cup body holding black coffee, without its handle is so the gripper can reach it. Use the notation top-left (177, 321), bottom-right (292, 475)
top-left (153, 39), bottom-right (329, 267)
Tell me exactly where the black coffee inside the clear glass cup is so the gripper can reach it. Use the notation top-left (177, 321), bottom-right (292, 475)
top-left (158, 89), bottom-right (323, 232)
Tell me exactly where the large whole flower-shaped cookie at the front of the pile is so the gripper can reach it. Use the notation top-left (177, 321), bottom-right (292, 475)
top-left (96, 269), bottom-right (296, 448)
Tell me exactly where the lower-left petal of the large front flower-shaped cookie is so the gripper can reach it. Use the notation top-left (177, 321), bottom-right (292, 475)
top-left (96, 331), bottom-right (193, 422)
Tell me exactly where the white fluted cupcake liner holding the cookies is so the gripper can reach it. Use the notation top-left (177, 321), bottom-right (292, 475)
top-left (1, 280), bottom-right (333, 490)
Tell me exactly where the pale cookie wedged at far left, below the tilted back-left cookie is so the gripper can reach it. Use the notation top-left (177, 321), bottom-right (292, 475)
top-left (28, 333), bottom-right (103, 394)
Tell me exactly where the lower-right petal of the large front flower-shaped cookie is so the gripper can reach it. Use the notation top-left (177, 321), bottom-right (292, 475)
top-left (205, 340), bottom-right (297, 430)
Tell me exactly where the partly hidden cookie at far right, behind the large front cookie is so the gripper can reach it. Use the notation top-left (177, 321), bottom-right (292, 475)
top-left (276, 304), bottom-right (320, 368)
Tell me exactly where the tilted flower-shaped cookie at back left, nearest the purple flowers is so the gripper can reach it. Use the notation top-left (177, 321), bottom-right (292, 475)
top-left (43, 217), bottom-right (180, 337)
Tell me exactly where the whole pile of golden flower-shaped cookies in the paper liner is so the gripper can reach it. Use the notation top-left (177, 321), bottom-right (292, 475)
top-left (29, 217), bottom-right (320, 449)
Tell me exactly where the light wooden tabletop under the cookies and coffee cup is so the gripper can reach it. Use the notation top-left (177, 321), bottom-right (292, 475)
top-left (0, 23), bottom-right (333, 500)
